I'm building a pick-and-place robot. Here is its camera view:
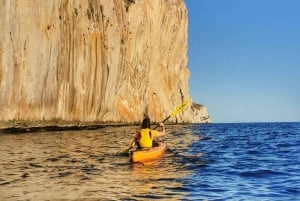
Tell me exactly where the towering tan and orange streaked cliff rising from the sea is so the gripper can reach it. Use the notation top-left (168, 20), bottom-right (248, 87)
top-left (0, 0), bottom-right (209, 128)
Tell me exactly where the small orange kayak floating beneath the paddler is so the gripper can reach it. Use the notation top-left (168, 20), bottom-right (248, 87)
top-left (129, 142), bottom-right (166, 163)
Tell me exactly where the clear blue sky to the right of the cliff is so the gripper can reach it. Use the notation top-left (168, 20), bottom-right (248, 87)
top-left (185, 0), bottom-right (300, 123)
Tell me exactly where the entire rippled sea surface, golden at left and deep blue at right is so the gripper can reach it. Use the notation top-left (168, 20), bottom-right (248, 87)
top-left (0, 123), bottom-right (300, 201)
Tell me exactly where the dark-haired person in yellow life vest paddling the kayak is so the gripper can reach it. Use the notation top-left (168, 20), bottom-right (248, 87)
top-left (130, 115), bottom-right (166, 149)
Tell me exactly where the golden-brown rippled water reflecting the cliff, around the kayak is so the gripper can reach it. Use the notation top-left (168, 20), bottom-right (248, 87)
top-left (0, 126), bottom-right (197, 200)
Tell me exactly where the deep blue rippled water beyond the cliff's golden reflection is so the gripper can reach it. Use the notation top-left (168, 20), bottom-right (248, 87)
top-left (183, 123), bottom-right (300, 200)
